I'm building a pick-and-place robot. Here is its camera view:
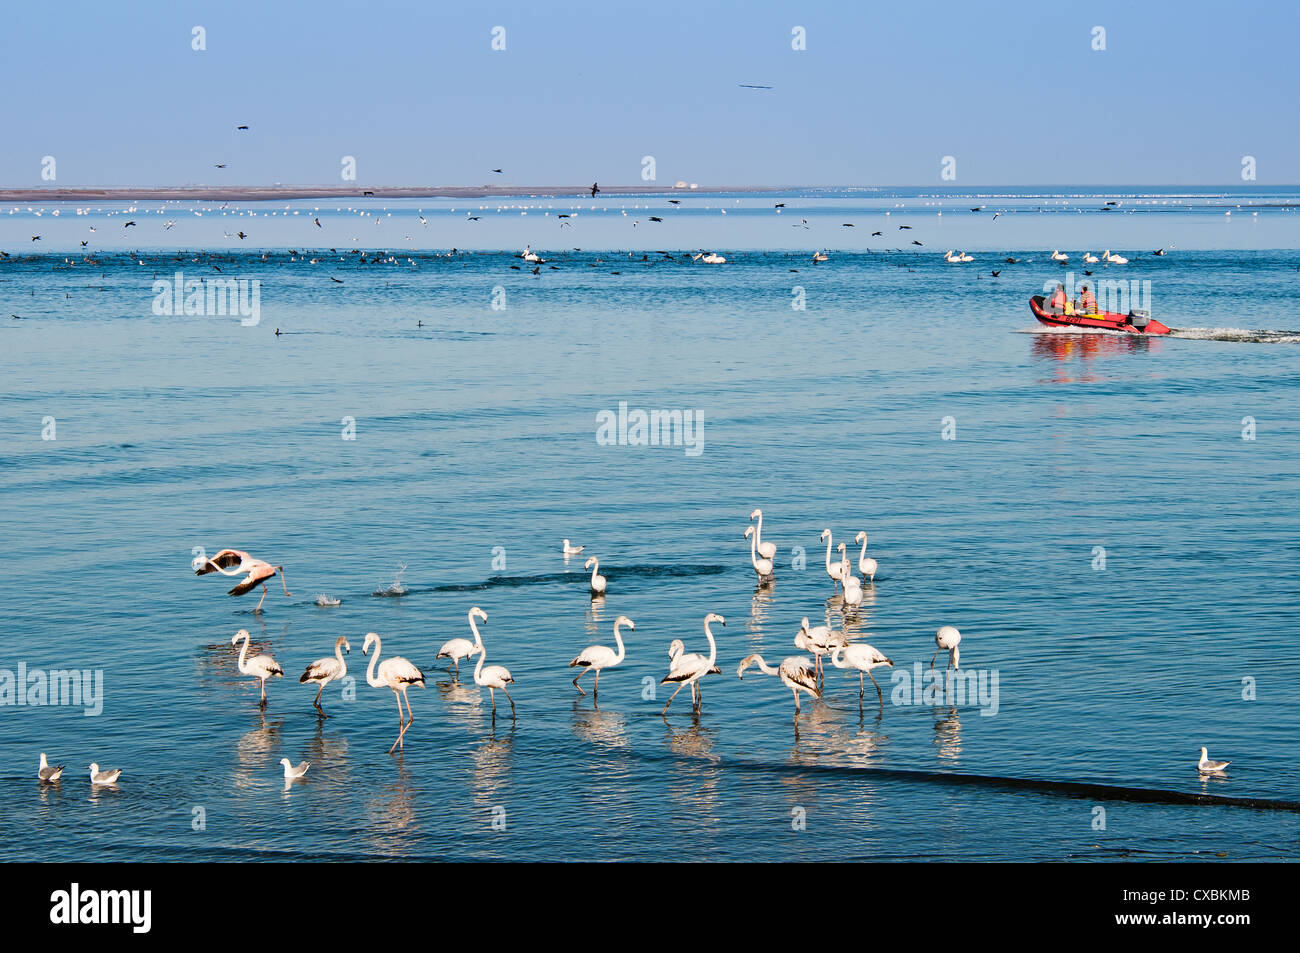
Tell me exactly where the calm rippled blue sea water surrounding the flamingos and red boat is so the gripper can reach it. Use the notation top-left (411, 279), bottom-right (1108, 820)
top-left (0, 187), bottom-right (1300, 861)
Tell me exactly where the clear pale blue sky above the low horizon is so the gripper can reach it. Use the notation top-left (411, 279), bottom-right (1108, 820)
top-left (0, 0), bottom-right (1300, 187)
